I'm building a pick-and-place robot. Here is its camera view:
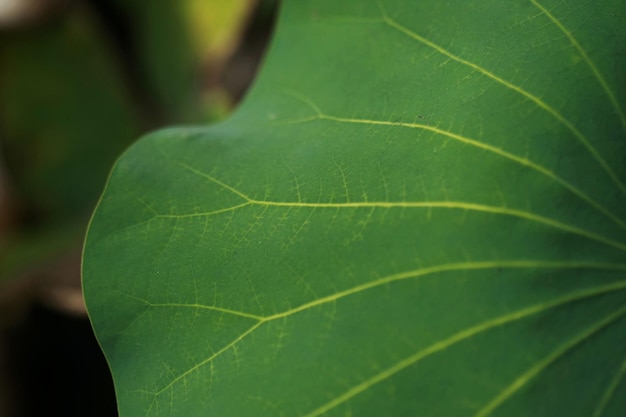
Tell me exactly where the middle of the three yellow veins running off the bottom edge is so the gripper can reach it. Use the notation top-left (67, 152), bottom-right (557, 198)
top-left (474, 307), bottom-right (626, 417)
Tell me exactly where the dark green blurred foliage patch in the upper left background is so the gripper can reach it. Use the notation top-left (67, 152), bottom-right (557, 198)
top-left (0, 10), bottom-right (141, 218)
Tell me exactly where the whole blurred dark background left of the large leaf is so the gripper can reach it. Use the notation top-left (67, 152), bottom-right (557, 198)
top-left (0, 0), bottom-right (276, 417)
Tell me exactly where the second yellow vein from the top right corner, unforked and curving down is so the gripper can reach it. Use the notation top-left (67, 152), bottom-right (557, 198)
top-left (372, 5), bottom-right (626, 194)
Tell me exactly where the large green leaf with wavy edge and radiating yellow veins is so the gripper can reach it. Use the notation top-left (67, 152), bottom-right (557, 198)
top-left (84, 0), bottom-right (626, 417)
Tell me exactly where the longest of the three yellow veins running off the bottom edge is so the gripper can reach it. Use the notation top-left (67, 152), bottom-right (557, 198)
top-left (305, 283), bottom-right (625, 417)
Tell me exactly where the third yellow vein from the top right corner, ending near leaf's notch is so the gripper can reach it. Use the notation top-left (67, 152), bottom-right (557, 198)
top-left (317, 112), bottom-right (626, 230)
